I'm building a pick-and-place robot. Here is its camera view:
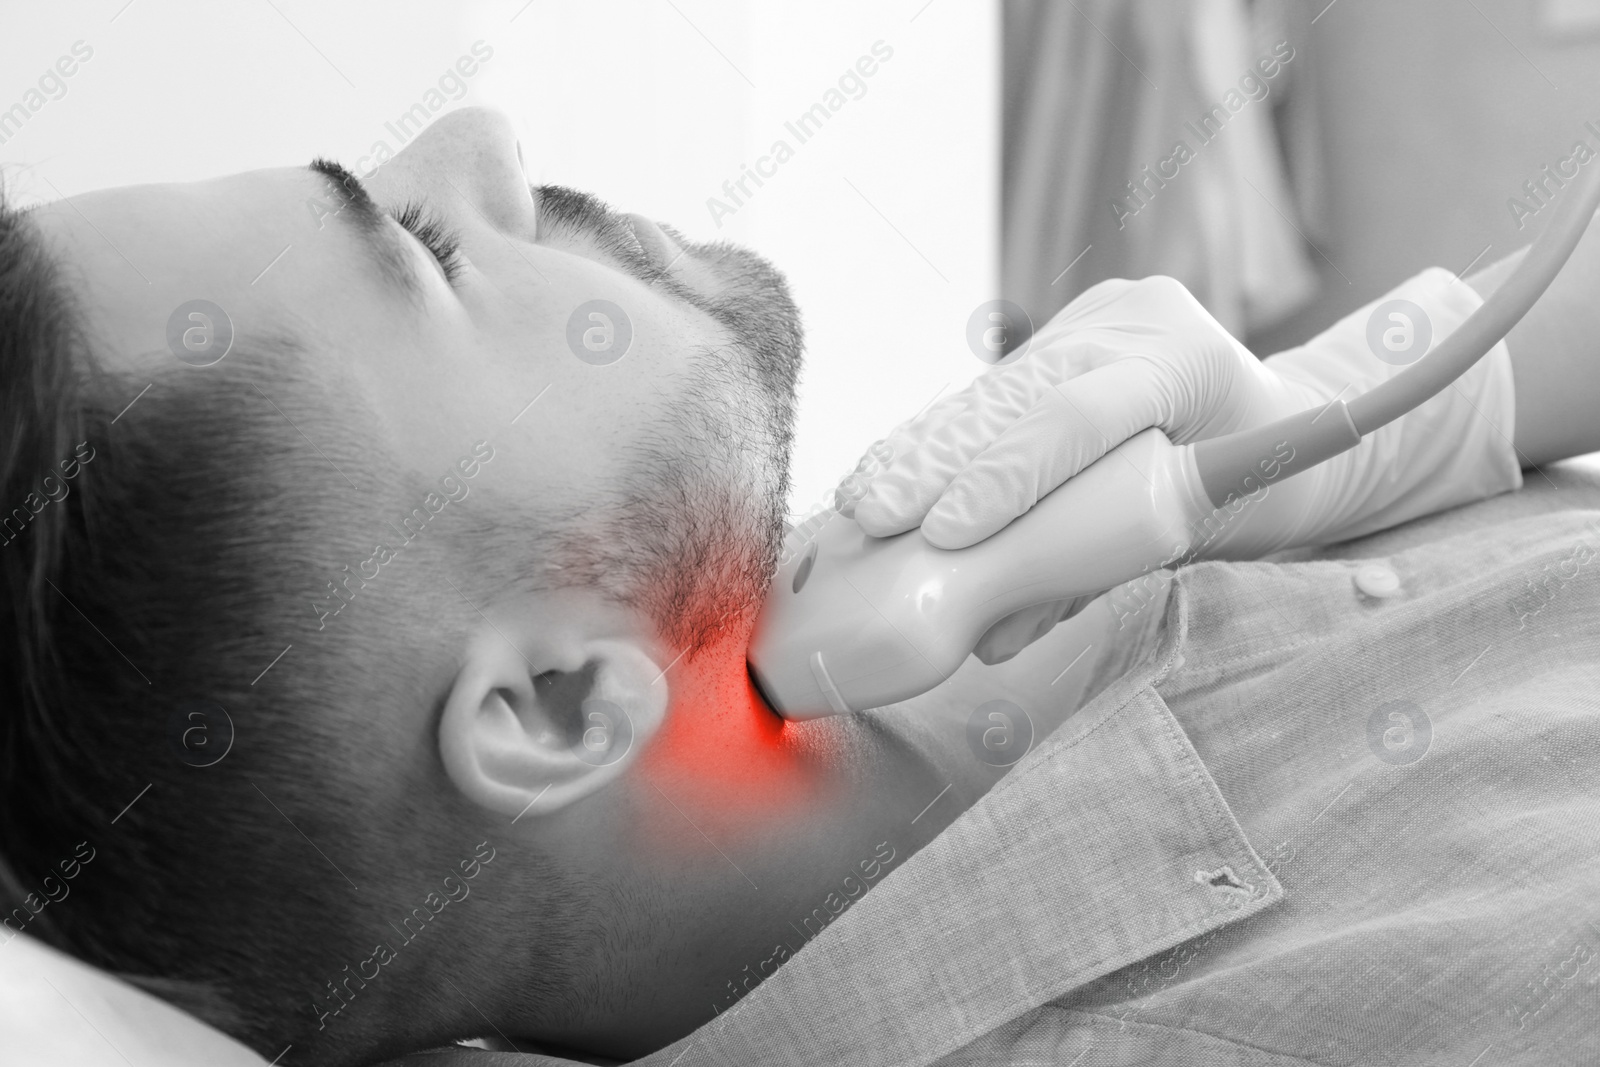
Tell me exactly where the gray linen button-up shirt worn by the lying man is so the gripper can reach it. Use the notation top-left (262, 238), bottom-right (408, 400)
top-left (396, 467), bottom-right (1600, 1067)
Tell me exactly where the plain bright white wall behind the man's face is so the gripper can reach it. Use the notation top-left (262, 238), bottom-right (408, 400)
top-left (0, 0), bottom-right (998, 512)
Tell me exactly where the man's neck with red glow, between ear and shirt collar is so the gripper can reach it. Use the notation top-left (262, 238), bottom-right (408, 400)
top-left (507, 632), bottom-right (953, 1057)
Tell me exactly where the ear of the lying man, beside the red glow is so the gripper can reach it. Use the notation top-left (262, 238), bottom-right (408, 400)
top-left (438, 601), bottom-right (667, 821)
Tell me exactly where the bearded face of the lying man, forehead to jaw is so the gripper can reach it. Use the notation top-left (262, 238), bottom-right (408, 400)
top-left (45, 109), bottom-right (800, 659)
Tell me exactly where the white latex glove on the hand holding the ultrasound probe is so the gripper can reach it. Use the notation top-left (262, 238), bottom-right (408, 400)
top-left (840, 267), bottom-right (1522, 662)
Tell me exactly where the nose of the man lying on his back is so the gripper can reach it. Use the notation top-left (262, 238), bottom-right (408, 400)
top-left (368, 107), bottom-right (536, 238)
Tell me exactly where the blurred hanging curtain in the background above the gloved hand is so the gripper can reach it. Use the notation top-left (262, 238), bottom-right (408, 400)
top-left (1000, 0), bottom-right (1320, 338)
